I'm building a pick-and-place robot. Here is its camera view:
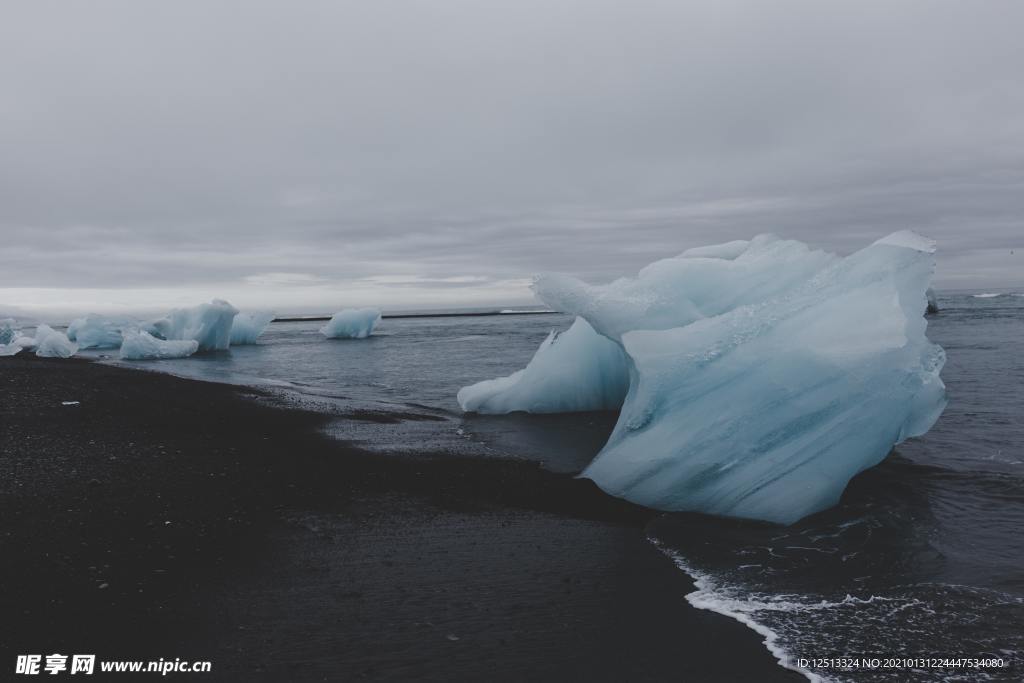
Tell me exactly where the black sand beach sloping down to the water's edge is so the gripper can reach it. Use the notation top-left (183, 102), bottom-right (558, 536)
top-left (0, 354), bottom-right (802, 681)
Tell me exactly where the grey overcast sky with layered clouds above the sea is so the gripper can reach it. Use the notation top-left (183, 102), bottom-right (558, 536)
top-left (0, 0), bottom-right (1024, 312)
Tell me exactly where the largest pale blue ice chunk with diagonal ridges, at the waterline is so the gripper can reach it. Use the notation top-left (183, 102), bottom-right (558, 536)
top-left (460, 231), bottom-right (945, 524)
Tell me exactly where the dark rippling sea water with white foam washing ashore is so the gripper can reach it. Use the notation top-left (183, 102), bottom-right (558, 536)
top-left (90, 293), bottom-right (1024, 681)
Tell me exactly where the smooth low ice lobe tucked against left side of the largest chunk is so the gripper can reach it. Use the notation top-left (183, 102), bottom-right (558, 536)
top-left (458, 317), bottom-right (630, 415)
